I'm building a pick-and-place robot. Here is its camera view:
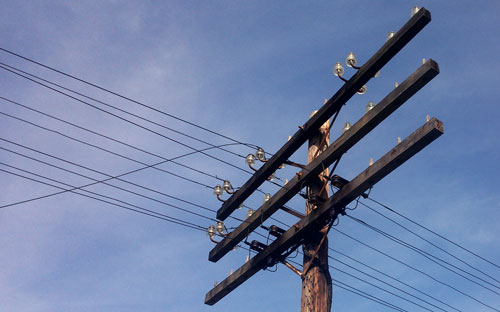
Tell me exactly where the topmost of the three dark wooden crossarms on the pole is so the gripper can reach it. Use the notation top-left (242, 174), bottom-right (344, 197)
top-left (217, 8), bottom-right (431, 220)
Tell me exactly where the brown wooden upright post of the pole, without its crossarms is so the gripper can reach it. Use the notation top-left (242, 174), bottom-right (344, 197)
top-left (300, 111), bottom-right (332, 312)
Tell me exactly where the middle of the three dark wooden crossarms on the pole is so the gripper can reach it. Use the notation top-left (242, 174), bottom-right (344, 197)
top-left (208, 59), bottom-right (439, 262)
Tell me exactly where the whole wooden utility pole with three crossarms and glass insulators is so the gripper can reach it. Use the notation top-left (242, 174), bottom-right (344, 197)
top-left (205, 8), bottom-right (444, 312)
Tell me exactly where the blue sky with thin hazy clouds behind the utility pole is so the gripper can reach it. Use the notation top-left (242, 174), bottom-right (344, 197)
top-left (0, 0), bottom-right (500, 311)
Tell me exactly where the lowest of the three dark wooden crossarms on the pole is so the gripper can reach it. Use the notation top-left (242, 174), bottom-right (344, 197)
top-left (205, 118), bottom-right (444, 305)
